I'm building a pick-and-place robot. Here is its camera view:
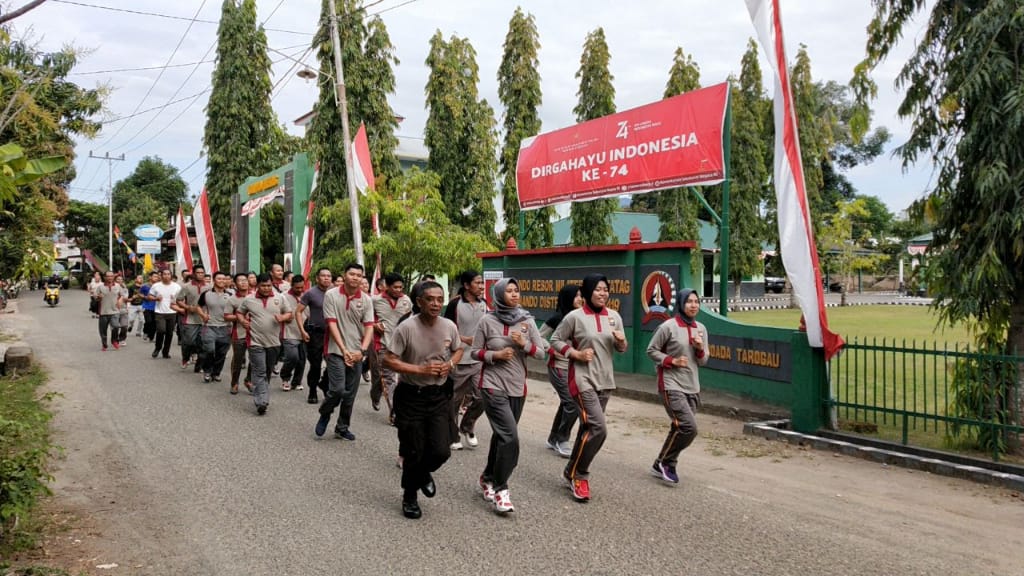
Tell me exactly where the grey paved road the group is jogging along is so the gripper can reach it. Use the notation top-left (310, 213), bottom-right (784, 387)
top-left (9, 291), bottom-right (1024, 575)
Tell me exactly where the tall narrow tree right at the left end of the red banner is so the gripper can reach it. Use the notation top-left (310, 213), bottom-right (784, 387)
top-left (498, 8), bottom-right (554, 248)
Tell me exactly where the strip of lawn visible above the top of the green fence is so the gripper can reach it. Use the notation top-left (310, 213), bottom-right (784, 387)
top-left (729, 305), bottom-right (971, 348)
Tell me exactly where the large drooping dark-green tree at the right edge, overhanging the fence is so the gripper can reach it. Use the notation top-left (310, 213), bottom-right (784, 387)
top-left (853, 0), bottom-right (1024, 451)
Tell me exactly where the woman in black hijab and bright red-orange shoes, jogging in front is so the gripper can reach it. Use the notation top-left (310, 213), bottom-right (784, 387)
top-left (551, 274), bottom-right (628, 502)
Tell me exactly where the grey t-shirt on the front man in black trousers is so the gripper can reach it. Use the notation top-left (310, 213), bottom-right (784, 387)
top-left (388, 315), bottom-right (461, 386)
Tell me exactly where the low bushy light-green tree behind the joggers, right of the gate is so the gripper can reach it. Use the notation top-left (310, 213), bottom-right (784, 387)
top-left (317, 168), bottom-right (496, 283)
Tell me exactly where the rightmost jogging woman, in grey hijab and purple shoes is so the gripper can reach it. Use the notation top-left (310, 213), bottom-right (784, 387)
top-left (647, 288), bottom-right (708, 484)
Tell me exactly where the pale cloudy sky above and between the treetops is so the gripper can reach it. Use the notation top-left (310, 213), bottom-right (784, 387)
top-left (12, 0), bottom-right (932, 213)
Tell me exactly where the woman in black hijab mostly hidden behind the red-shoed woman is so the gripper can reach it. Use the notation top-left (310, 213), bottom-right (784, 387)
top-left (541, 284), bottom-right (583, 458)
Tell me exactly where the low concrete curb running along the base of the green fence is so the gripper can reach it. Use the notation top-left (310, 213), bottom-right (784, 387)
top-left (743, 420), bottom-right (1024, 492)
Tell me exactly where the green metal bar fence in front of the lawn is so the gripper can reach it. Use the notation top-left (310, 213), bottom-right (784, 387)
top-left (826, 338), bottom-right (1024, 460)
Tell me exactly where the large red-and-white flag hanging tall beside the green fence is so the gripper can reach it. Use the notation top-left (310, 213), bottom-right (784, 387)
top-left (746, 0), bottom-right (844, 360)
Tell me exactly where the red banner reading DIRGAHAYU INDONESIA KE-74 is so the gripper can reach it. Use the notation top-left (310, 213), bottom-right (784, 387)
top-left (516, 83), bottom-right (729, 210)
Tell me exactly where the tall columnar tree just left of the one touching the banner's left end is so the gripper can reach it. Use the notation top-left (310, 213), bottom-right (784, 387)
top-left (424, 31), bottom-right (498, 238)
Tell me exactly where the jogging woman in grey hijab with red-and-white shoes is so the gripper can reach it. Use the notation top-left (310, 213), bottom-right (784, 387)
top-left (470, 278), bottom-right (548, 515)
